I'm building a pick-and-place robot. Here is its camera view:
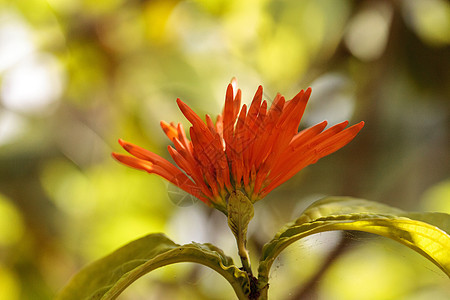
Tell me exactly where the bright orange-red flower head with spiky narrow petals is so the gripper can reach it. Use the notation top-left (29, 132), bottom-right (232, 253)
top-left (113, 79), bottom-right (364, 214)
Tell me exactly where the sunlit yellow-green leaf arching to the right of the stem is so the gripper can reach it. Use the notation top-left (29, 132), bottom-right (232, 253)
top-left (258, 197), bottom-right (450, 288)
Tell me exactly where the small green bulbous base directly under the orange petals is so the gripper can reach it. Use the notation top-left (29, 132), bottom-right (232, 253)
top-left (228, 191), bottom-right (254, 245)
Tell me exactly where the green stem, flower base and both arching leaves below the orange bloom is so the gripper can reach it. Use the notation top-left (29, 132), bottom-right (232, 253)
top-left (58, 197), bottom-right (450, 300)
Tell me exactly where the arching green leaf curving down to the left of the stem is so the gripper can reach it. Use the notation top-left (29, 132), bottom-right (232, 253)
top-left (57, 234), bottom-right (250, 300)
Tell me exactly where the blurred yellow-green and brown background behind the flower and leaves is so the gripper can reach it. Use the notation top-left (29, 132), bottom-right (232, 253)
top-left (0, 0), bottom-right (450, 300)
